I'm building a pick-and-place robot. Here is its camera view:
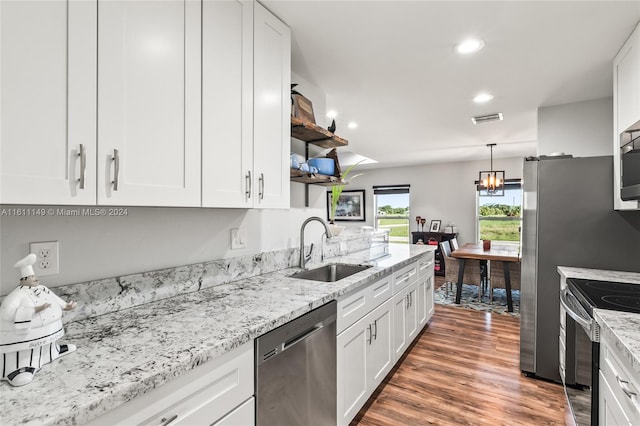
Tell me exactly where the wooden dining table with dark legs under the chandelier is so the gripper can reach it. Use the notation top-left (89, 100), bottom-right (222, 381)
top-left (451, 243), bottom-right (520, 312)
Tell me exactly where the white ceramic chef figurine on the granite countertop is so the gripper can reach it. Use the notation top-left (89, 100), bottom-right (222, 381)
top-left (0, 254), bottom-right (76, 386)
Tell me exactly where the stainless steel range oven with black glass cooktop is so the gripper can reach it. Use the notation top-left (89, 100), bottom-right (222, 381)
top-left (560, 278), bottom-right (640, 426)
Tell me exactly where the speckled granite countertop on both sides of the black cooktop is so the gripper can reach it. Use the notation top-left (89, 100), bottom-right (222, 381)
top-left (558, 266), bottom-right (640, 381)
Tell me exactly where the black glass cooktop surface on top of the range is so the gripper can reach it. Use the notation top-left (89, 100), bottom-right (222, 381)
top-left (567, 278), bottom-right (640, 315)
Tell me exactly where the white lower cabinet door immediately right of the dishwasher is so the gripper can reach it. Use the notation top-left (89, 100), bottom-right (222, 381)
top-left (336, 318), bottom-right (371, 425)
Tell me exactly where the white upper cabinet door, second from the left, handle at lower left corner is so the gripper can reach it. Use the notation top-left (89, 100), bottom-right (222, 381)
top-left (98, 0), bottom-right (201, 206)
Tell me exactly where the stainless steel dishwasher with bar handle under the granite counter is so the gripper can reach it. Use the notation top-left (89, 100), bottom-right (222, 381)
top-left (256, 301), bottom-right (337, 426)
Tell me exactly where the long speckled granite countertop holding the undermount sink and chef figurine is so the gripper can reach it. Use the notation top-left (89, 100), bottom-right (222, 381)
top-left (0, 244), bottom-right (435, 424)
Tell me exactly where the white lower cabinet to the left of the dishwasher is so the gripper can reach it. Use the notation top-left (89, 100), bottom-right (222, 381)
top-left (89, 341), bottom-right (255, 426)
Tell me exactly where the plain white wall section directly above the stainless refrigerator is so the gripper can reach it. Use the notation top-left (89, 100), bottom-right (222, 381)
top-left (538, 98), bottom-right (613, 157)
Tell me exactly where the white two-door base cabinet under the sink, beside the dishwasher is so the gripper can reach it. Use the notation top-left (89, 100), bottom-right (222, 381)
top-left (337, 300), bottom-right (393, 425)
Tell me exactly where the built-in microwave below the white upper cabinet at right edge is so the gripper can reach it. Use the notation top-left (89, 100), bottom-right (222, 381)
top-left (620, 121), bottom-right (640, 201)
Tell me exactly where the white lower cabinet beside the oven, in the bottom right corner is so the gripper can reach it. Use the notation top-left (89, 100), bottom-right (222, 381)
top-left (598, 336), bottom-right (640, 426)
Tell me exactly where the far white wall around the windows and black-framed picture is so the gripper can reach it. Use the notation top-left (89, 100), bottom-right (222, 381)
top-left (340, 158), bottom-right (523, 243)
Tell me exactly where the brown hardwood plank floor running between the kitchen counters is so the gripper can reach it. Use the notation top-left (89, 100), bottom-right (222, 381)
top-left (352, 305), bottom-right (573, 426)
